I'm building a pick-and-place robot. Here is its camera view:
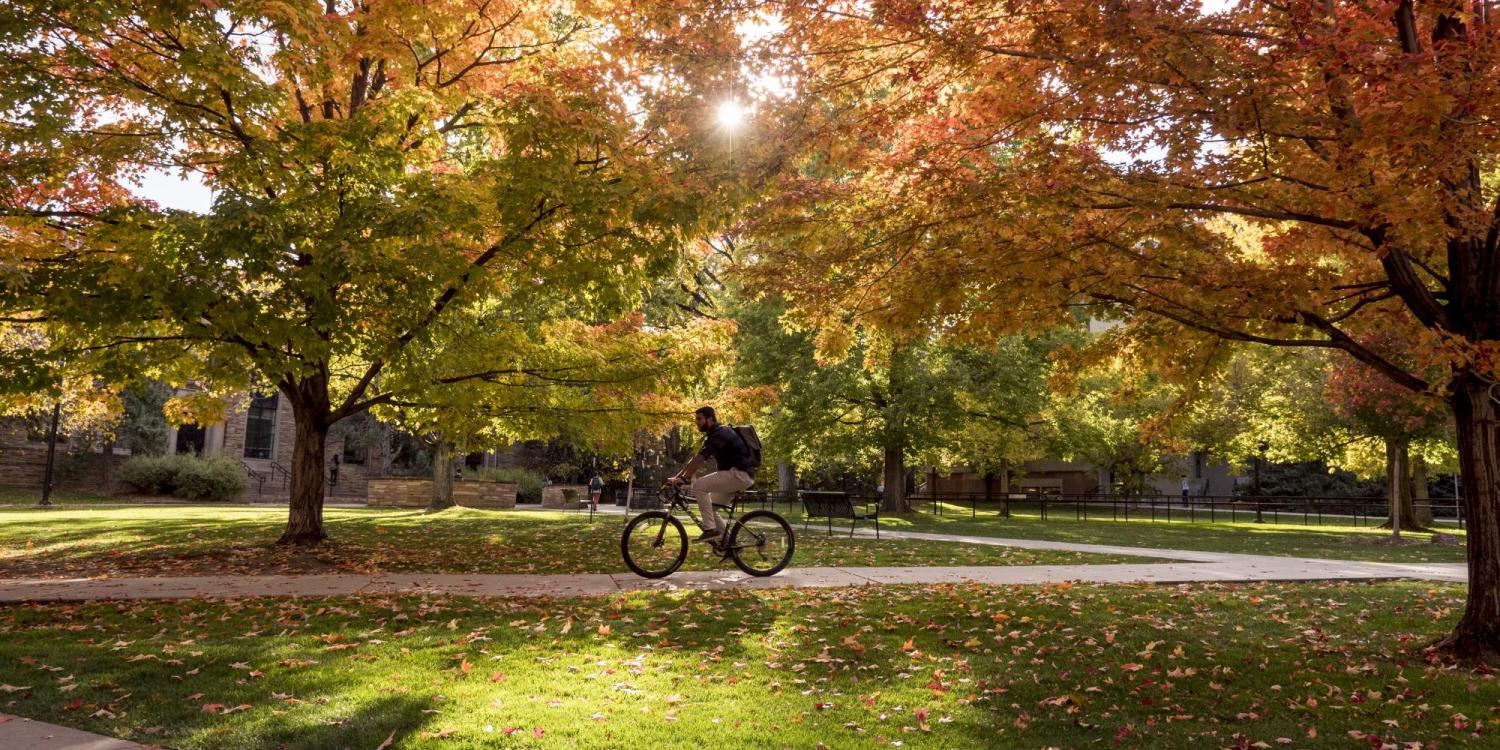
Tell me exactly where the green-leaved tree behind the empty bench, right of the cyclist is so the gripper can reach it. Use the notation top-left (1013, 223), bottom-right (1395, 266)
top-left (722, 297), bottom-right (1067, 513)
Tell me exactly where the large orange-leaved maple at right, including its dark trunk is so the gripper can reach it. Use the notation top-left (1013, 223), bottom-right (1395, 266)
top-left (756, 0), bottom-right (1500, 662)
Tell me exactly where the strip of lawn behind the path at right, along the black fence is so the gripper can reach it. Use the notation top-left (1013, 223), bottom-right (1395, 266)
top-left (834, 504), bottom-right (1464, 563)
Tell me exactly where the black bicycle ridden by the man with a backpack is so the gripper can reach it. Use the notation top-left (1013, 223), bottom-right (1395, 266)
top-left (620, 485), bottom-right (797, 578)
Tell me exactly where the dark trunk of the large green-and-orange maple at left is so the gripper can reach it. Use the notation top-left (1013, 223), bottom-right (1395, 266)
top-left (278, 378), bottom-right (330, 545)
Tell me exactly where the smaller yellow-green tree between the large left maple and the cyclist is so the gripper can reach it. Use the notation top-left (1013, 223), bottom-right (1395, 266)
top-left (374, 314), bottom-right (729, 510)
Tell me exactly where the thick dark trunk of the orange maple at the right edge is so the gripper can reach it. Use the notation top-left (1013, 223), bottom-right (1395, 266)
top-left (1437, 377), bottom-right (1500, 665)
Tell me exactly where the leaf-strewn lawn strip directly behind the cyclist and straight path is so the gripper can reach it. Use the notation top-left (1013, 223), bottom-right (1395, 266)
top-left (0, 506), bottom-right (1154, 578)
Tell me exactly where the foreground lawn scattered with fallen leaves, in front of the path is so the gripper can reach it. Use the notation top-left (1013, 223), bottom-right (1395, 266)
top-left (0, 584), bottom-right (1482, 750)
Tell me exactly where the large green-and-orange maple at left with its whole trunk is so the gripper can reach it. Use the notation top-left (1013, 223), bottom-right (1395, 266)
top-left (0, 0), bottom-right (756, 543)
